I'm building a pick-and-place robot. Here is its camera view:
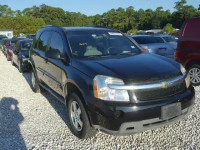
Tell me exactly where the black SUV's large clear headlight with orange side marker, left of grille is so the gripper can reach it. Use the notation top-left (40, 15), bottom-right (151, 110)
top-left (93, 75), bottom-right (129, 102)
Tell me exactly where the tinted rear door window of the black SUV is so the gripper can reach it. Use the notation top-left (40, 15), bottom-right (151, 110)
top-left (38, 31), bottom-right (51, 51)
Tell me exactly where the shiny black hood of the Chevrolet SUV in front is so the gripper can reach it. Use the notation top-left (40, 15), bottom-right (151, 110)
top-left (72, 53), bottom-right (181, 83)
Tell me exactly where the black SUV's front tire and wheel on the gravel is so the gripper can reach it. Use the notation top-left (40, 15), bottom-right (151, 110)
top-left (67, 93), bottom-right (97, 139)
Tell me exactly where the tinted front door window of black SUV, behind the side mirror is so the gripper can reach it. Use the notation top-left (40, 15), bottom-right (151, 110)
top-left (49, 32), bottom-right (63, 53)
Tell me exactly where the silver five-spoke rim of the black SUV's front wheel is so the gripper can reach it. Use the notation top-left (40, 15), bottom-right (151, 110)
top-left (70, 101), bottom-right (83, 131)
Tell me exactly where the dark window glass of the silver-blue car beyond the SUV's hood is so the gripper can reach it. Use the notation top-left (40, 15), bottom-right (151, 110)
top-left (132, 36), bottom-right (165, 44)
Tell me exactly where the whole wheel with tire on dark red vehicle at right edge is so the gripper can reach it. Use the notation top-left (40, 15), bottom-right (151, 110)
top-left (188, 64), bottom-right (200, 86)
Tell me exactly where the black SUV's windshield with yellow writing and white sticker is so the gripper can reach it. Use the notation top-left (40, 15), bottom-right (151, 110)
top-left (67, 30), bottom-right (141, 58)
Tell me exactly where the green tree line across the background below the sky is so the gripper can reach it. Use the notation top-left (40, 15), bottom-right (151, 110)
top-left (0, 0), bottom-right (200, 35)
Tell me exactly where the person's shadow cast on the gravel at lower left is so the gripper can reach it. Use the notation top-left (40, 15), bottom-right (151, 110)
top-left (0, 97), bottom-right (27, 150)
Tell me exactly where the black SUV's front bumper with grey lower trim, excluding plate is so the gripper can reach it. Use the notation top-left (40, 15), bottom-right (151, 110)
top-left (89, 87), bottom-right (195, 135)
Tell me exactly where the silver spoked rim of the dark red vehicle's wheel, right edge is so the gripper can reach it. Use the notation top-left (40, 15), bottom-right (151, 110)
top-left (188, 68), bottom-right (200, 84)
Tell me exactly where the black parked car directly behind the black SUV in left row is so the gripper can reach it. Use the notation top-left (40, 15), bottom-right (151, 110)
top-left (11, 39), bottom-right (33, 72)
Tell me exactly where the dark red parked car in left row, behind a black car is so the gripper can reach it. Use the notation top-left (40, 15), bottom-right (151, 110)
top-left (5, 37), bottom-right (24, 61)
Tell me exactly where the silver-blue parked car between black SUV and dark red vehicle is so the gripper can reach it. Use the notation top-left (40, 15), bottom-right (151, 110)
top-left (131, 35), bottom-right (175, 59)
